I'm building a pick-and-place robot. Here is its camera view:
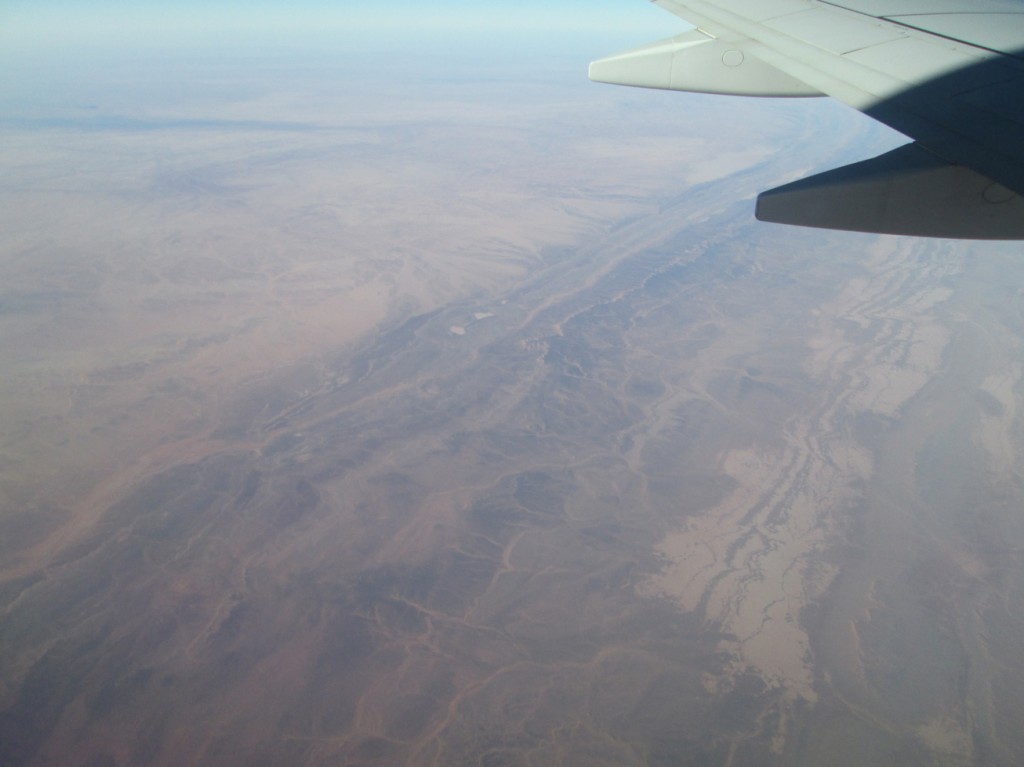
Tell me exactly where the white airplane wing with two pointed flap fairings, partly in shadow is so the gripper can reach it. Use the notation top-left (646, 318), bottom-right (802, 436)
top-left (590, 0), bottom-right (1024, 240)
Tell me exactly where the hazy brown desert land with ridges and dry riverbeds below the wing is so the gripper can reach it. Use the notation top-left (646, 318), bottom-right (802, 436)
top-left (0, 23), bottom-right (1024, 766)
